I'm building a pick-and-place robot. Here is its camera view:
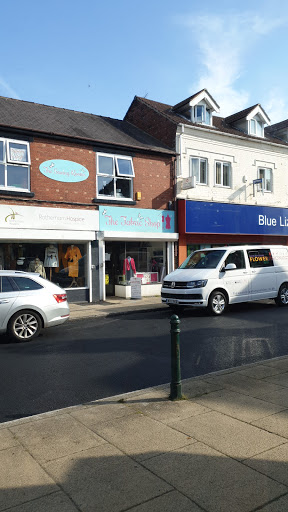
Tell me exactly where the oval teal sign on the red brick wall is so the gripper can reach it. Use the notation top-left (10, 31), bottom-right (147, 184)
top-left (39, 160), bottom-right (89, 183)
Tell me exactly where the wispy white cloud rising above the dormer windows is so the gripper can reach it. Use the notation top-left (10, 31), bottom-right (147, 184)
top-left (182, 12), bottom-right (287, 118)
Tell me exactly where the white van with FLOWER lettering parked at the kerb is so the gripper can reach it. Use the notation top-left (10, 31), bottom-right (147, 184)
top-left (161, 245), bottom-right (288, 315)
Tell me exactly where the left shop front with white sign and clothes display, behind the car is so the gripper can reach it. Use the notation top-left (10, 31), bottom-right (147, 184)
top-left (0, 205), bottom-right (99, 302)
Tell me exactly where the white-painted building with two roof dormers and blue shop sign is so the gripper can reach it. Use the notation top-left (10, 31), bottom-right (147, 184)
top-left (125, 89), bottom-right (288, 263)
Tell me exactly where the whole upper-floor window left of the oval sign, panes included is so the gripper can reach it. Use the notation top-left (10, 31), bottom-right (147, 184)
top-left (0, 139), bottom-right (30, 191)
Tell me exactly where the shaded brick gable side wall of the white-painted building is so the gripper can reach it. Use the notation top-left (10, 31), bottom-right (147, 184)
top-left (125, 99), bottom-right (177, 149)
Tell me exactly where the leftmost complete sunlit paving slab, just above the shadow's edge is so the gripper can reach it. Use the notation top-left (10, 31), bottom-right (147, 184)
top-left (10, 414), bottom-right (105, 463)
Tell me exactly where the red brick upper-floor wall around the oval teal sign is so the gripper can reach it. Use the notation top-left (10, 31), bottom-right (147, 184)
top-left (0, 138), bottom-right (174, 210)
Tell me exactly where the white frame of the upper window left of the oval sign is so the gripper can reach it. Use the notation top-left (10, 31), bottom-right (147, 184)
top-left (0, 137), bottom-right (31, 192)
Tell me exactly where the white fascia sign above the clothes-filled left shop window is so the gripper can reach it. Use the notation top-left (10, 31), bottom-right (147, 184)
top-left (0, 205), bottom-right (99, 231)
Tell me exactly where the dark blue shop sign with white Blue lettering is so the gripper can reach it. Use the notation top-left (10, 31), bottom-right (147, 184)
top-left (184, 201), bottom-right (288, 235)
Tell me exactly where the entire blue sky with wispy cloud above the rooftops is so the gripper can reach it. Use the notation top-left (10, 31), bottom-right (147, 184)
top-left (0, 0), bottom-right (288, 123)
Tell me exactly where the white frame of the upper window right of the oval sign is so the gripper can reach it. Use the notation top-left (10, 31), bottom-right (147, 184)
top-left (96, 152), bottom-right (135, 201)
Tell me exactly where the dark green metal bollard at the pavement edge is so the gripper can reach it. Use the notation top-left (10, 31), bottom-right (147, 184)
top-left (169, 315), bottom-right (182, 400)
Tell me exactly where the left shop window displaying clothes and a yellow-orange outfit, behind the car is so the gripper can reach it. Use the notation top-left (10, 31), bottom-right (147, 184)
top-left (0, 242), bottom-right (88, 290)
